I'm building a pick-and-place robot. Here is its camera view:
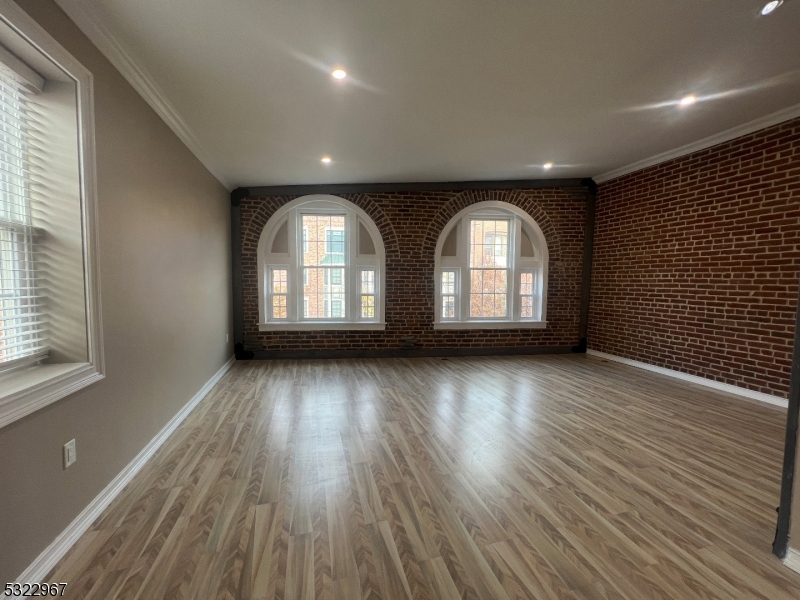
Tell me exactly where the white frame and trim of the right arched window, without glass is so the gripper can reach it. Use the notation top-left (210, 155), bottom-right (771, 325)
top-left (434, 201), bottom-right (548, 329)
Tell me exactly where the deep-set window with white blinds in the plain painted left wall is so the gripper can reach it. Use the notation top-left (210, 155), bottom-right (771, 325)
top-left (0, 2), bottom-right (104, 427)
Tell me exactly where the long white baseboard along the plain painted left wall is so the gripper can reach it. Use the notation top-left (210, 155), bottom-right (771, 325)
top-left (16, 356), bottom-right (236, 581)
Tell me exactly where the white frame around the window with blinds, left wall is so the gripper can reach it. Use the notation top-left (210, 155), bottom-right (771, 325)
top-left (0, 0), bottom-right (105, 427)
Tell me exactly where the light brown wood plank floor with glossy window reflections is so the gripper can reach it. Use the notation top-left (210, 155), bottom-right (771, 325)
top-left (50, 355), bottom-right (800, 600)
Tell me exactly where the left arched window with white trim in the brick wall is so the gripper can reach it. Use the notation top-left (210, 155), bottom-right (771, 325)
top-left (258, 195), bottom-right (386, 331)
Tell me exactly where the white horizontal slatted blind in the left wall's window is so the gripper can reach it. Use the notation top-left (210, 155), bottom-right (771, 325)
top-left (0, 68), bottom-right (47, 370)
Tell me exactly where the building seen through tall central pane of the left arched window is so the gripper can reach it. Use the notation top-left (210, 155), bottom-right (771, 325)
top-left (302, 215), bottom-right (347, 319)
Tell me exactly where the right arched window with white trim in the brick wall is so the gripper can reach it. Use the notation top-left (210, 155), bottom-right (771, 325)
top-left (434, 202), bottom-right (547, 329)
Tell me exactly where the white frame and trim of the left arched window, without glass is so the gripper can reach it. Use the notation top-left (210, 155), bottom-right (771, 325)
top-left (257, 194), bottom-right (386, 331)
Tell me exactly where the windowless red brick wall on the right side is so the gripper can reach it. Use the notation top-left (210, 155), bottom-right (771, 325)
top-left (589, 119), bottom-right (800, 397)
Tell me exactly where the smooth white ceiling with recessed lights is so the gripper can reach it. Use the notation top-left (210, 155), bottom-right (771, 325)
top-left (57, 0), bottom-right (800, 187)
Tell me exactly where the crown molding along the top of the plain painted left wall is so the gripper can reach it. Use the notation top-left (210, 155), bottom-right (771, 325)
top-left (56, 0), bottom-right (234, 191)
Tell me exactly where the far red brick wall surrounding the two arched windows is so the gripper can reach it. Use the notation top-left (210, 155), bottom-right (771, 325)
top-left (241, 190), bottom-right (586, 350)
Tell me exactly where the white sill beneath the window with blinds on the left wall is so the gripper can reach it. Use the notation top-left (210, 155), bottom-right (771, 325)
top-left (0, 363), bottom-right (103, 427)
